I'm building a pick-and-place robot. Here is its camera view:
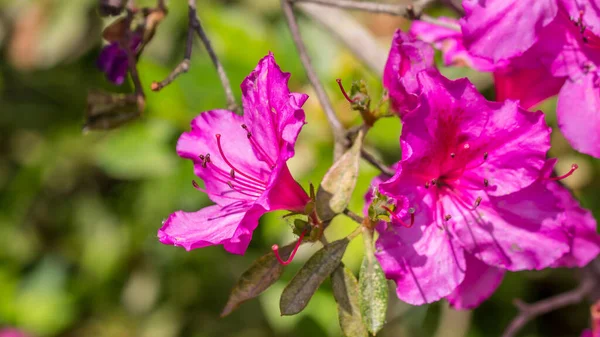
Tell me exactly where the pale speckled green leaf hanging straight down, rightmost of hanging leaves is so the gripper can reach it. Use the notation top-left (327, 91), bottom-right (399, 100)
top-left (359, 228), bottom-right (388, 335)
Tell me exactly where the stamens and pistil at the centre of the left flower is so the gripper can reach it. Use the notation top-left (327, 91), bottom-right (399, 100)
top-left (192, 124), bottom-right (275, 200)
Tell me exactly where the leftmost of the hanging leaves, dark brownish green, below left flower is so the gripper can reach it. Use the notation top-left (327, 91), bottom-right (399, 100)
top-left (221, 243), bottom-right (295, 317)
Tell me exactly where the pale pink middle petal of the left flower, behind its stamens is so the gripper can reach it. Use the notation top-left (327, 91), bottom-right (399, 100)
top-left (177, 110), bottom-right (271, 205)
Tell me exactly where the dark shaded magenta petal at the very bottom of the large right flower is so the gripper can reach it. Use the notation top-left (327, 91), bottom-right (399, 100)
top-left (446, 253), bottom-right (504, 309)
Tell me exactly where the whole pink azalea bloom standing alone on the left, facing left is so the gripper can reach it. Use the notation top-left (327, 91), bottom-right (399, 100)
top-left (158, 54), bottom-right (309, 254)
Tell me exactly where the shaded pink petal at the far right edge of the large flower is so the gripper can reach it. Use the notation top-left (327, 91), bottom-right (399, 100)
top-left (546, 181), bottom-right (600, 267)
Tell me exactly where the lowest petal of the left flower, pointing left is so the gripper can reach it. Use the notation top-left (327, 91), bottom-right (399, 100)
top-left (158, 202), bottom-right (264, 254)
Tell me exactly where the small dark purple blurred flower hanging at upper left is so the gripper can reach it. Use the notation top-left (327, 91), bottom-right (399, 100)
top-left (97, 34), bottom-right (142, 85)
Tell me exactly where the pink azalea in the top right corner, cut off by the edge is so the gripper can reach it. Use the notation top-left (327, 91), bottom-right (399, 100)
top-left (461, 0), bottom-right (600, 157)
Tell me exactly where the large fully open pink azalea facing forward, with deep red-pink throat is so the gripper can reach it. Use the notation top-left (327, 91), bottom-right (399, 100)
top-left (373, 33), bottom-right (599, 308)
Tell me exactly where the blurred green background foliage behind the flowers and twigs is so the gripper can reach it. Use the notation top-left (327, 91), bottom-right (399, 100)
top-left (0, 0), bottom-right (600, 337)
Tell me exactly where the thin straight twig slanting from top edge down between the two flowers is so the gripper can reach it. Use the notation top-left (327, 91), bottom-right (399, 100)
top-left (281, 0), bottom-right (346, 158)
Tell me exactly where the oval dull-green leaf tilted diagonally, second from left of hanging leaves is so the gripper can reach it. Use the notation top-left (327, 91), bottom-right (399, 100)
top-left (279, 238), bottom-right (350, 315)
